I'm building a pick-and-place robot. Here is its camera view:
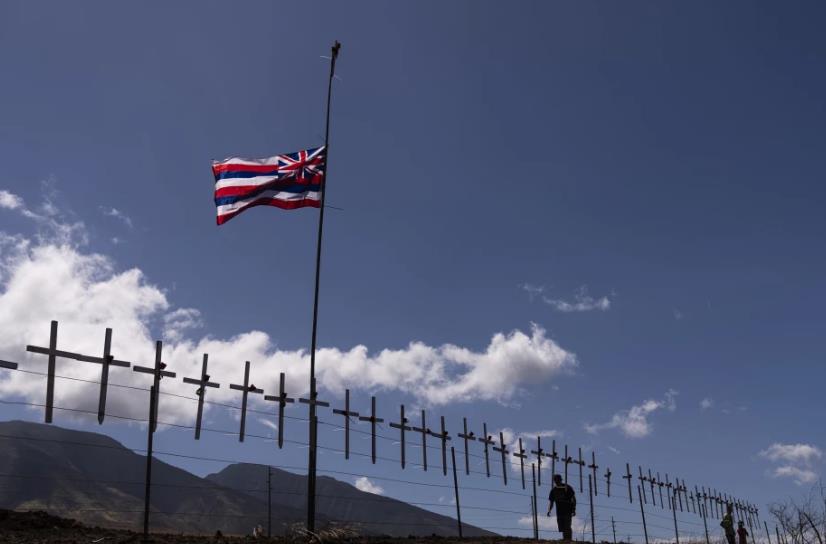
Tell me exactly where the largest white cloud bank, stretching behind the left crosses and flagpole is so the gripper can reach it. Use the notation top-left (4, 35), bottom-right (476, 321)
top-left (0, 196), bottom-right (578, 422)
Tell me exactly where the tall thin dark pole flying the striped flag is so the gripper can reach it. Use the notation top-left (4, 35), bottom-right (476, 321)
top-left (307, 41), bottom-right (341, 532)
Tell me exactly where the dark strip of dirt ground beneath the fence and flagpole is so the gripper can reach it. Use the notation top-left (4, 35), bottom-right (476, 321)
top-left (0, 510), bottom-right (572, 544)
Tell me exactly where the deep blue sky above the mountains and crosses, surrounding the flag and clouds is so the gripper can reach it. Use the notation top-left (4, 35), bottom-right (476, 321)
top-left (0, 2), bottom-right (826, 536)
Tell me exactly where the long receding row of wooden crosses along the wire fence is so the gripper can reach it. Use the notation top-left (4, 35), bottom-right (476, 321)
top-left (16, 321), bottom-right (759, 526)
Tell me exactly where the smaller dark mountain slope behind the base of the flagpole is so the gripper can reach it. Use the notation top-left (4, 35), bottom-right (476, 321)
top-left (206, 463), bottom-right (494, 536)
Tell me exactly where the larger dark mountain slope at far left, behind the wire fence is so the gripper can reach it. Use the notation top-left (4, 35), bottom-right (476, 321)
top-left (0, 421), bottom-right (304, 533)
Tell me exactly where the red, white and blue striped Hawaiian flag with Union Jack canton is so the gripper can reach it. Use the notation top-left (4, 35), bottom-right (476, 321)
top-left (212, 146), bottom-right (325, 225)
